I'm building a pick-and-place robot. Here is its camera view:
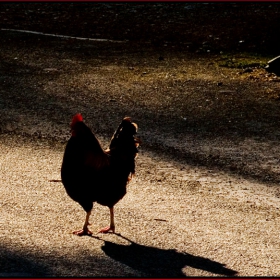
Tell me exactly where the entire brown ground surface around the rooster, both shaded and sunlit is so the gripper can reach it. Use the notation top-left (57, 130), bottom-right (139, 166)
top-left (0, 2), bottom-right (280, 277)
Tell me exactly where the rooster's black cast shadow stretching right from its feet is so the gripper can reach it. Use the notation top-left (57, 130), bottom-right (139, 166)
top-left (97, 234), bottom-right (237, 278)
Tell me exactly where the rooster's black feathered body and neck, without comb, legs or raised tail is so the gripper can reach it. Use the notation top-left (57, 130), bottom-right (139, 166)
top-left (61, 117), bottom-right (137, 215)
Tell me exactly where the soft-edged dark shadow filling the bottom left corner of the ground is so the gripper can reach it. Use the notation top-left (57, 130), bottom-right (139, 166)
top-left (0, 244), bottom-right (139, 278)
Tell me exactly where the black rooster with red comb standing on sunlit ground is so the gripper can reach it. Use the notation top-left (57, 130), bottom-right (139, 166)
top-left (61, 114), bottom-right (140, 236)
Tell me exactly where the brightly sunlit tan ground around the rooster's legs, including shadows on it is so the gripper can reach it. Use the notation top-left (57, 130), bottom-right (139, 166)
top-left (0, 135), bottom-right (280, 277)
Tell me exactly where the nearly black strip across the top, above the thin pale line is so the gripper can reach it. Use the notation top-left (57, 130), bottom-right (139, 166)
top-left (0, 2), bottom-right (280, 55)
